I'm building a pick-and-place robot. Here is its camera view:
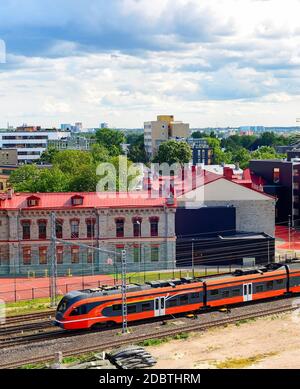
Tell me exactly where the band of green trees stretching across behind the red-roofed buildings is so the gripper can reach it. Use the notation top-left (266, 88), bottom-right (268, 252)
top-left (9, 129), bottom-right (293, 192)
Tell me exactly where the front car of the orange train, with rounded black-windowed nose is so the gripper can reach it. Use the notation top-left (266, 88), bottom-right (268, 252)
top-left (56, 278), bottom-right (204, 330)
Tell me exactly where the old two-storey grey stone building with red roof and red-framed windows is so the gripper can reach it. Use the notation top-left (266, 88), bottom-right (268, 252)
top-left (0, 193), bottom-right (176, 276)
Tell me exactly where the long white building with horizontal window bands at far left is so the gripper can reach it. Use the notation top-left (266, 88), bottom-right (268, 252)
top-left (0, 127), bottom-right (70, 164)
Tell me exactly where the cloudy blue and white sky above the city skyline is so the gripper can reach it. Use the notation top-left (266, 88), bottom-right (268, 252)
top-left (0, 0), bottom-right (300, 128)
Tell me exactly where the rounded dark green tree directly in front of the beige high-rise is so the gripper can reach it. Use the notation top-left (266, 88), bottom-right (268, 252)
top-left (154, 140), bottom-right (192, 165)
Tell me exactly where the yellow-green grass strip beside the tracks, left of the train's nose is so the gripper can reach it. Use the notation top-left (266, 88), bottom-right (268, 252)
top-left (6, 297), bottom-right (61, 317)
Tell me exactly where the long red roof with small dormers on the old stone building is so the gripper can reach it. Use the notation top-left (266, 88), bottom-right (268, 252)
top-left (0, 192), bottom-right (176, 210)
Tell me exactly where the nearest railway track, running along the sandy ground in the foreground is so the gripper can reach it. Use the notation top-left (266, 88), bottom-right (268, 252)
top-left (0, 304), bottom-right (296, 369)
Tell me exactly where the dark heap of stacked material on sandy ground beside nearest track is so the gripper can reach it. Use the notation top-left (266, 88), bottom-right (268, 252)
top-left (107, 346), bottom-right (156, 369)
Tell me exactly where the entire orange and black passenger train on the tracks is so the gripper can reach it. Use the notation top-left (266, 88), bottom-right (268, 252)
top-left (55, 260), bottom-right (300, 330)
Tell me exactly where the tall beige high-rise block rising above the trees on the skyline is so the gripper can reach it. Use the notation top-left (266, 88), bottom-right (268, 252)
top-left (144, 115), bottom-right (190, 158)
